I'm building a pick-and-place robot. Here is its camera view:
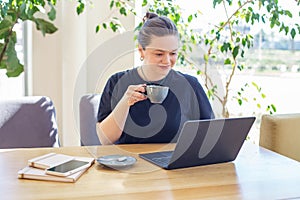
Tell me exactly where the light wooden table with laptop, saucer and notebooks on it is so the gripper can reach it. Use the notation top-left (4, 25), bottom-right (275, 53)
top-left (0, 143), bottom-right (300, 200)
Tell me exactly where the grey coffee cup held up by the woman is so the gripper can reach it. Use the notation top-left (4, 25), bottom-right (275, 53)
top-left (146, 85), bottom-right (169, 103)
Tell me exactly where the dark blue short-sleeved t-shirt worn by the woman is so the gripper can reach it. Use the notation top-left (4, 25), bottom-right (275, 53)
top-left (98, 68), bottom-right (214, 144)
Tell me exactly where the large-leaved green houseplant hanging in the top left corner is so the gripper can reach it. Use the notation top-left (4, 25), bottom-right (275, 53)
top-left (0, 0), bottom-right (57, 77)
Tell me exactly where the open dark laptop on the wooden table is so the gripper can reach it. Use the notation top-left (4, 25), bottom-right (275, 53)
top-left (139, 117), bottom-right (255, 169)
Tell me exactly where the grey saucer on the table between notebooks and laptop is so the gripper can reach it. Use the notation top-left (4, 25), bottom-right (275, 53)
top-left (97, 155), bottom-right (136, 168)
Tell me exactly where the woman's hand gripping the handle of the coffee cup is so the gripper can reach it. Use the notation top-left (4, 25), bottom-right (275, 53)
top-left (123, 84), bottom-right (147, 106)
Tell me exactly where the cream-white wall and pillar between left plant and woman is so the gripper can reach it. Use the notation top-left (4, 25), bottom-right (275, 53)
top-left (31, 0), bottom-right (134, 146)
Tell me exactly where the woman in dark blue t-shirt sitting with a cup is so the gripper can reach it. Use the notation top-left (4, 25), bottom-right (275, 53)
top-left (97, 13), bottom-right (214, 144)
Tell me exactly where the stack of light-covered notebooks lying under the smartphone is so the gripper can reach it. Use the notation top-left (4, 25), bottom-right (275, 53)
top-left (18, 153), bottom-right (95, 183)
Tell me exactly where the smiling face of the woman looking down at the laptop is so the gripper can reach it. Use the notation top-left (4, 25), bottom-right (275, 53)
top-left (139, 35), bottom-right (178, 75)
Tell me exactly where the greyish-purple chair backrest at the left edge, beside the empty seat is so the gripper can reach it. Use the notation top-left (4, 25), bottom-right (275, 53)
top-left (0, 96), bottom-right (58, 148)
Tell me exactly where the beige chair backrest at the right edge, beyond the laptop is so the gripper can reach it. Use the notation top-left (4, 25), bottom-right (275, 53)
top-left (259, 113), bottom-right (300, 161)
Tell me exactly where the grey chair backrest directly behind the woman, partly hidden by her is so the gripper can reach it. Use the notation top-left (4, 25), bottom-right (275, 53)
top-left (79, 94), bottom-right (101, 146)
